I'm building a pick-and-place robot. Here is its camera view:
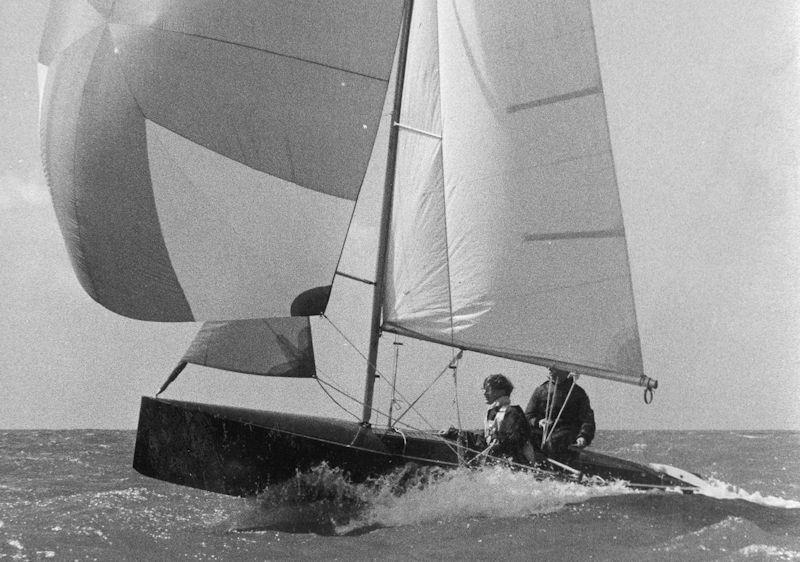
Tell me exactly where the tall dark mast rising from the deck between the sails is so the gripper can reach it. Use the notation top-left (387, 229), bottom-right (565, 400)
top-left (361, 0), bottom-right (414, 425)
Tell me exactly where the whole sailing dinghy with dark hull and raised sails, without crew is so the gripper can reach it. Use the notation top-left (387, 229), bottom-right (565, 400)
top-left (40, 0), bottom-right (696, 495)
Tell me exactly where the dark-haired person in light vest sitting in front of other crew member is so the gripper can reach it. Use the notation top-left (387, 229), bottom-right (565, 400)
top-left (483, 374), bottom-right (534, 464)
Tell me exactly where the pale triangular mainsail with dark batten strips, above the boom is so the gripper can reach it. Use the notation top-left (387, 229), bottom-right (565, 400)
top-left (384, 0), bottom-right (646, 384)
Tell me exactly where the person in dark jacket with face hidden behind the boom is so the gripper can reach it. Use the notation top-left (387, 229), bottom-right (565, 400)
top-left (525, 367), bottom-right (595, 453)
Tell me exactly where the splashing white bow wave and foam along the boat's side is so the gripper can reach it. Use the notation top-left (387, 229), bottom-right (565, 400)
top-left (232, 465), bottom-right (634, 534)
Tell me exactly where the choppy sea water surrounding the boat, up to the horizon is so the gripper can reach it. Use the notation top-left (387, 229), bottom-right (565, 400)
top-left (0, 430), bottom-right (800, 560)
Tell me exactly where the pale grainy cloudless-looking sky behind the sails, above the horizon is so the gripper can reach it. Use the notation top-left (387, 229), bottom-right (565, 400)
top-left (0, 0), bottom-right (800, 430)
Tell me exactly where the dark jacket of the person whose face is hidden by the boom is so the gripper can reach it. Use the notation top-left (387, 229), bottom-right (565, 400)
top-left (525, 378), bottom-right (595, 450)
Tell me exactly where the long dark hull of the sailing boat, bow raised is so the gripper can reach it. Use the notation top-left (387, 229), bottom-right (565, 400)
top-left (133, 397), bottom-right (686, 496)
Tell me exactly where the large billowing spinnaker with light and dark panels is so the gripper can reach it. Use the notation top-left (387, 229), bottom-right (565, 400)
top-left (40, 0), bottom-right (402, 321)
